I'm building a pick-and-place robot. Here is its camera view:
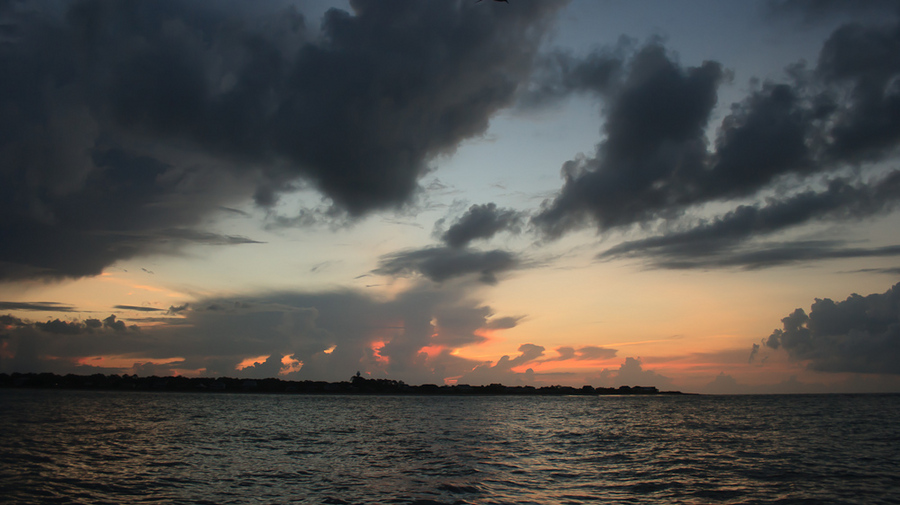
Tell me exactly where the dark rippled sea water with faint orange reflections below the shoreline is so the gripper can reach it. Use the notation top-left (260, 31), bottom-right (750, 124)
top-left (0, 390), bottom-right (900, 504)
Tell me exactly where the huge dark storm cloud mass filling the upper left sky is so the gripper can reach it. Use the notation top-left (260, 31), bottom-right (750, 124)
top-left (0, 0), bottom-right (564, 279)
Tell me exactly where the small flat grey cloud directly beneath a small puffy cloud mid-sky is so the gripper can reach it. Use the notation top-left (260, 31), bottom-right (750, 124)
top-left (372, 247), bottom-right (520, 284)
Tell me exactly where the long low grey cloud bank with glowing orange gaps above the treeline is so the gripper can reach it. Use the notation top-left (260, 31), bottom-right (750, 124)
top-left (0, 285), bottom-right (530, 383)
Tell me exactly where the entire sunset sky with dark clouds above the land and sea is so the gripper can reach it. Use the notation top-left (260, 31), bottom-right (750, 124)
top-left (0, 0), bottom-right (900, 393)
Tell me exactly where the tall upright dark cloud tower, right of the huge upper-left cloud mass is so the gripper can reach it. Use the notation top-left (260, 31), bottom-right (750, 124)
top-left (534, 44), bottom-right (723, 236)
